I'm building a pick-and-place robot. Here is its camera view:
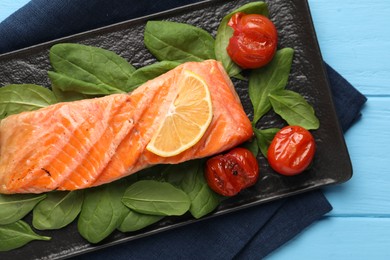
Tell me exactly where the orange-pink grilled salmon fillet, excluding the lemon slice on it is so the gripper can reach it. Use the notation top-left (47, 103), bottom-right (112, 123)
top-left (0, 60), bottom-right (253, 194)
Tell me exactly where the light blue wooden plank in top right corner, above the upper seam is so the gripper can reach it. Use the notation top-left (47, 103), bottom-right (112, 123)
top-left (309, 0), bottom-right (390, 95)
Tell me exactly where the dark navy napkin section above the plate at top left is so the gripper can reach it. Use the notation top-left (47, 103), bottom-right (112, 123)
top-left (0, 0), bottom-right (200, 54)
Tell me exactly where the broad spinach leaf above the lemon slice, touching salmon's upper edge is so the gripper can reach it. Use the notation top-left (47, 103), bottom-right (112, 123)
top-left (144, 21), bottom-right (215, 63)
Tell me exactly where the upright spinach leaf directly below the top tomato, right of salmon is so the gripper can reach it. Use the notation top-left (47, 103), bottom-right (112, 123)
top-left (249, 48), bottom-right (294, 124)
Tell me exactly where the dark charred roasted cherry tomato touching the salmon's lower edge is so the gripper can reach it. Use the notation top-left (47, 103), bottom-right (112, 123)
top-left (205, 148), bottom-right (259, 196)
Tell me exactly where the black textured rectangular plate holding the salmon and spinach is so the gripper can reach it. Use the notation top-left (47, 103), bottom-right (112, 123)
top-left (0, 0), bottom-right (352, 260)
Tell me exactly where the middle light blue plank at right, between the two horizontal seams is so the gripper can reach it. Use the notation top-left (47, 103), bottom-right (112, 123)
top-left (325, 97), bottom-right (390, 216)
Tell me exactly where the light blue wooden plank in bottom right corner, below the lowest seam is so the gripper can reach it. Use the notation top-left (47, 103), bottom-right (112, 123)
top-left (266, 217), bottom-right (390, 260)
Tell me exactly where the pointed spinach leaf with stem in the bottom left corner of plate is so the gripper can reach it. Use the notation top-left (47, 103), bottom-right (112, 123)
top-left (0, 220), bottom-right (51, 252)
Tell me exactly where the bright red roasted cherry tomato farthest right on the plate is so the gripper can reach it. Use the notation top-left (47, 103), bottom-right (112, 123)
top-left (267, 126), bottom-right (316, 176)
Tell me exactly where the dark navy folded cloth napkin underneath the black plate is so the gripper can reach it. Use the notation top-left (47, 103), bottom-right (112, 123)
top-left (0, 0), bottom-right (366, 260)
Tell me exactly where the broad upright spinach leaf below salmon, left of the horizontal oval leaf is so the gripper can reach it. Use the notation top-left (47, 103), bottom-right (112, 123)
top-left (77, 179), bottom-right (127, 243)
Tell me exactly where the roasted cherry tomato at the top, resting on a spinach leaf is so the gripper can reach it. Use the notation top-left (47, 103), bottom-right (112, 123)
top-left (226, 12), bottom-right (278, 69)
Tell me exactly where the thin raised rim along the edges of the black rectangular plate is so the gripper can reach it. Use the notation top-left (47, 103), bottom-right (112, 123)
top-left (0, 0), bottom-right (353, 259)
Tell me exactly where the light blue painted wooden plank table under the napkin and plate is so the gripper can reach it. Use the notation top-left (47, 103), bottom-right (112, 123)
top-left (0, 0), bottom-right (390, 260)
